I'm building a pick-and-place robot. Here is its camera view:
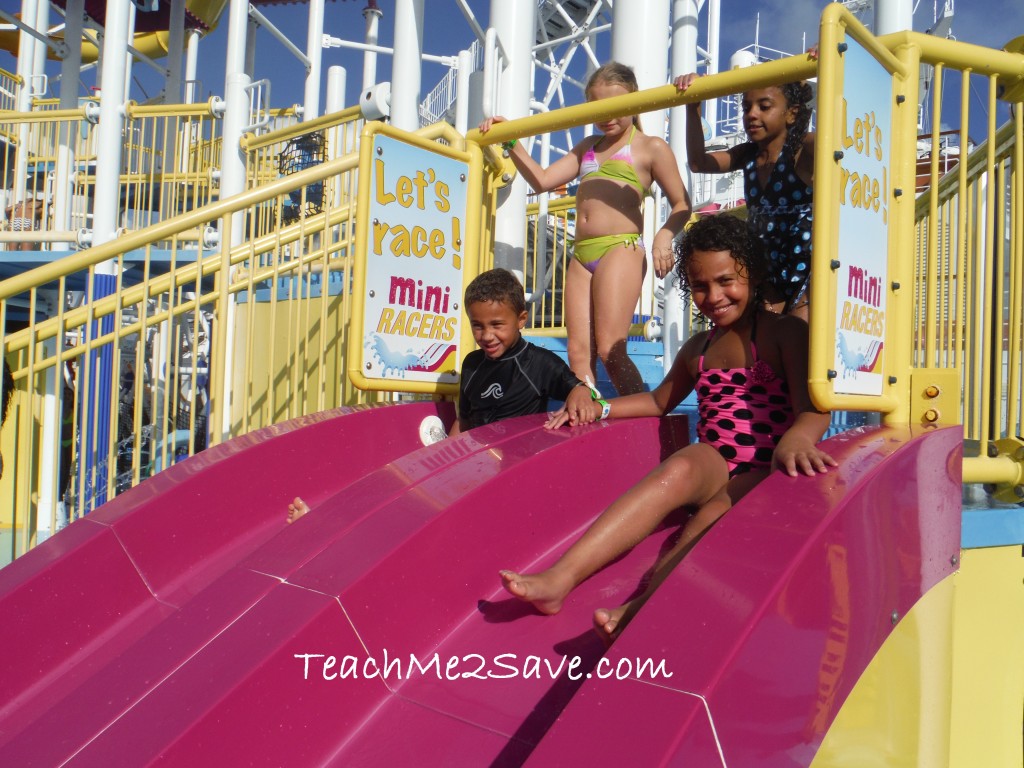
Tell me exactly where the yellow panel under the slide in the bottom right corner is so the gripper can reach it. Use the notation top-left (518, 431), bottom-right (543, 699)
top-left (811, 547), bottom-right (1024, 768)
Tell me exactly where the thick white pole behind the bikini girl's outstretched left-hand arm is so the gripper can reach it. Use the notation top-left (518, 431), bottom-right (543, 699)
top-left (485, 0), bottom-right (537, 271)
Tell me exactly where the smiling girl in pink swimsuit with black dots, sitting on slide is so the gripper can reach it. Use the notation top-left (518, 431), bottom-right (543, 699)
top-left (501, 215), bottom-right (836, 641)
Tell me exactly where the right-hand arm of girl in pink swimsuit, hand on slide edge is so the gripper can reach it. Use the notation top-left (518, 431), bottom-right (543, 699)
top-left (772, 316), bottom-right (839, 477)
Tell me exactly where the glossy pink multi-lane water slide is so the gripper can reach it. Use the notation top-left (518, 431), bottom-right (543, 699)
top-left (0, 403), bottom-right (962, 767)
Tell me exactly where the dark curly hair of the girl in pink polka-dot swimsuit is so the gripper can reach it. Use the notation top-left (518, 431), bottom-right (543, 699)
top-left (676, 213), bottom-right (771, 301)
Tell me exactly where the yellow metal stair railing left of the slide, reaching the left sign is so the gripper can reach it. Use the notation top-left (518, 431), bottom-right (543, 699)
top-left (0, 121), bottom-right (493, 560)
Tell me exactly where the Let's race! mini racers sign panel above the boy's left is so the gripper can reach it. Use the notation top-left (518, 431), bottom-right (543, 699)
top-left (353, 133), bottom-right (469, 391)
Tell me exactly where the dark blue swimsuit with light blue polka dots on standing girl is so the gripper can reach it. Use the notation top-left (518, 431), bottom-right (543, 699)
top-left (743, 150), bottom-right (812, 311)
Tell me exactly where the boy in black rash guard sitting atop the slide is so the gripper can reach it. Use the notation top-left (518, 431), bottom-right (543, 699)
top-left (451, 269), bottom-right (587, 435)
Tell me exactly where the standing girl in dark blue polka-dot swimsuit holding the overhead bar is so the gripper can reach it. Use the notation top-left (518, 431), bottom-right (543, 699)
top-left (676, 68), bottom-right (814, 319)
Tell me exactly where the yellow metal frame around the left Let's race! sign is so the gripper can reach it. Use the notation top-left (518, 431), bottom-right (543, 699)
top-left (348, 121), bottom-right (487, 394)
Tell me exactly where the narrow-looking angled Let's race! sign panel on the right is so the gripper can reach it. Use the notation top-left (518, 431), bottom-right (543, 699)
top-left (833, 37), bottom-right (892, 395)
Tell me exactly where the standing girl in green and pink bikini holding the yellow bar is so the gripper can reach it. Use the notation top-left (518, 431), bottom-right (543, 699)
top-left (480, 61), bottom-right (690, 395)
